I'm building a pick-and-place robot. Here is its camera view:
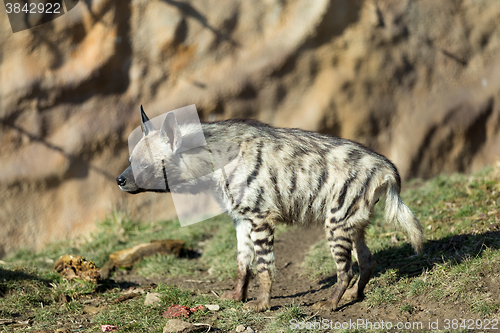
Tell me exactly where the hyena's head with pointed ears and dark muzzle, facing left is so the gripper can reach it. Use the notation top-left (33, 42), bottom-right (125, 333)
top-left (116, 106), bottom-right (188, 194)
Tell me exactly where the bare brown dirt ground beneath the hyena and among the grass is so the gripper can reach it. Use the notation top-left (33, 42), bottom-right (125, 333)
top-left (114, 228), bottom-right (496, 331)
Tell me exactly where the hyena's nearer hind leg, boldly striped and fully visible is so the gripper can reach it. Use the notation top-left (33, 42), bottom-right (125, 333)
top-left (313, 218), bottom-right (354, 310)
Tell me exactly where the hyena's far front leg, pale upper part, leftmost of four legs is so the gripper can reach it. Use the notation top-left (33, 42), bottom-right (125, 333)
top-left (221, 220), bottom-right (254, 301)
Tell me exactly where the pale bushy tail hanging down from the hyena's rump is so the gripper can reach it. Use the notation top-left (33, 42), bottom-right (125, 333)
top-left (385, 175), bottom-right (423, 253)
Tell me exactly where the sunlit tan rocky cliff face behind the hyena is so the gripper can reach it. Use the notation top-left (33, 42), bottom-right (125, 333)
top-left (0, 0), bottom-right (500, 255)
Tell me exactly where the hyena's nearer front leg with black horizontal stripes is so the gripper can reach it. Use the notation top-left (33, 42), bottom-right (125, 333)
top-left (244, 220), bottom-right (275, 311)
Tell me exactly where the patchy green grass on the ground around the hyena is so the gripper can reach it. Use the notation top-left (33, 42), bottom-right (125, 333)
top-left (0, 169), bottom-right (500, 332)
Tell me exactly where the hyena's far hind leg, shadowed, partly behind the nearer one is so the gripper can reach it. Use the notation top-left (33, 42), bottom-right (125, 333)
top-left (344, 231), bottom-right (377, 301)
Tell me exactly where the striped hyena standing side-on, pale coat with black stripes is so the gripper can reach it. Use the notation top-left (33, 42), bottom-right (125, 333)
top-left (116, 110), bottom-right (422, 311)
